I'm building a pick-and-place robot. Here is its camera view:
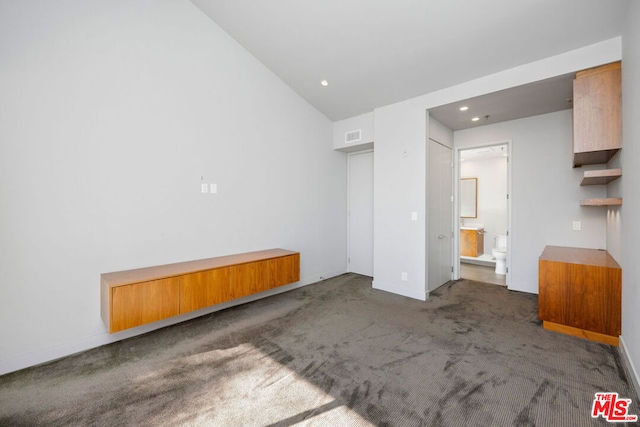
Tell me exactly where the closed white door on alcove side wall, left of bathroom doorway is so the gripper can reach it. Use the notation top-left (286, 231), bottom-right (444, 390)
top-left (427, 139), bottom-right (453, 291)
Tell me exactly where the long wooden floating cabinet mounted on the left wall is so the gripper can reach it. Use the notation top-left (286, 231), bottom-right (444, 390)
top-left (100, 249), bottom-right (300, 333)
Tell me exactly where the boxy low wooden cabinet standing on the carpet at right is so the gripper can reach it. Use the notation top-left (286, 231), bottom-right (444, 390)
top-left (538, 246), bottom-right (622, 346)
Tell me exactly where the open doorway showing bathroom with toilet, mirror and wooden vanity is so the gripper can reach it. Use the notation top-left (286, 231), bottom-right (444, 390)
top-left (456, 141), bottom-right (511, 286)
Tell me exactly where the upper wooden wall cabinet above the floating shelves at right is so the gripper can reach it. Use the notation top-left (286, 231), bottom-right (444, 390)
top-left (573, 61), bottom-right (622, 167)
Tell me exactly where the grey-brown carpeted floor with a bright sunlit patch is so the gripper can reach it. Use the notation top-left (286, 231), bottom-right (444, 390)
top-left (0, 274), bottom-right (640, 426)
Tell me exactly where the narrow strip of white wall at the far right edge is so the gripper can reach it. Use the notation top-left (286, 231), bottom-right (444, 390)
top-left (620, 1), bottom-right (640, 393)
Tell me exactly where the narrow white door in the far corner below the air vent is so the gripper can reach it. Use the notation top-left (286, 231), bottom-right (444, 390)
top-left (347, 151), bottom-right (373, 277)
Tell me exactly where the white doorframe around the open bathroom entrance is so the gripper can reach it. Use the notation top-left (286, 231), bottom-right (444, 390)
top-left (452, 137), bottom-right (513, 289)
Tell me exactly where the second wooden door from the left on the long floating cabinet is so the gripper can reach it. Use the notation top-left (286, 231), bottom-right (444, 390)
top-left (180, 267), bottom-right (231, 313)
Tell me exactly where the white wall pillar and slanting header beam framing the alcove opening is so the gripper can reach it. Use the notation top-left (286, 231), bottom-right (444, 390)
top-left (374, 38), bottom-right (622, 299)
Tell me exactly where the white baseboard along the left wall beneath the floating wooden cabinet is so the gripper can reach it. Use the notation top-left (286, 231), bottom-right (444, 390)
top-left (0, 270), bottom-right (346, 375)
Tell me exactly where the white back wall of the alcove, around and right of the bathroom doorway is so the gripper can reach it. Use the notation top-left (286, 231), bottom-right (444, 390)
top-left (454, 110), bottom-right (606, 293)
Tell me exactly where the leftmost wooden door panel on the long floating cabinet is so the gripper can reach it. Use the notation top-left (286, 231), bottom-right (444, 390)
top-left (110, 277), bottom-right (180, 333)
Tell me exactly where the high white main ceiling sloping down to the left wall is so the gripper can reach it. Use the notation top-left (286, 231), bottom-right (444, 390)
top-left (191, 0), bottom-right (627, 121)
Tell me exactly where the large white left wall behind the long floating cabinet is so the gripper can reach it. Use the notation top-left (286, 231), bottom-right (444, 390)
top-left (0, 0), bottom-right (346, 374)
